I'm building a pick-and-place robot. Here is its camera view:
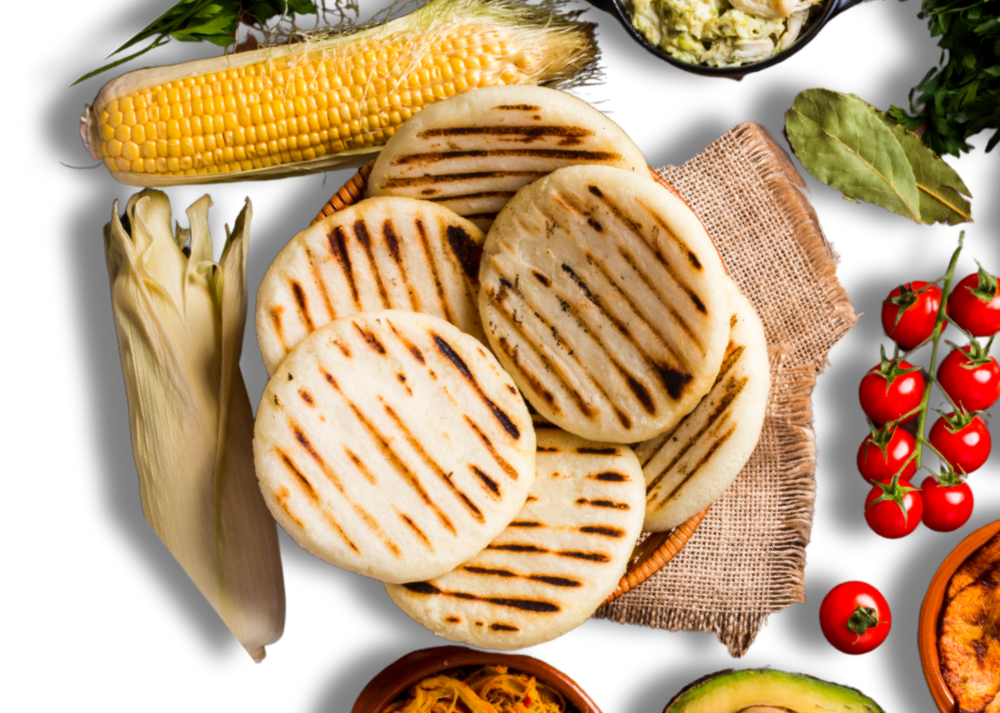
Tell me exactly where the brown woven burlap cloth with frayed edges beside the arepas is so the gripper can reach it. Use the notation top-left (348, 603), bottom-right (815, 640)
top-left (594, 122), bottom-right (858, 658)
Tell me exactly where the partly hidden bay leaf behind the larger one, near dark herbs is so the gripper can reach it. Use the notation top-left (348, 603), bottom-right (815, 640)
top-left (872, 107), bottom-right (976, 225)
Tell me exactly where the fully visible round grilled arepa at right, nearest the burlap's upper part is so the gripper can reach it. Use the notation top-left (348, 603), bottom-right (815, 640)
top-left (479, 166), bottom-right (732, 443)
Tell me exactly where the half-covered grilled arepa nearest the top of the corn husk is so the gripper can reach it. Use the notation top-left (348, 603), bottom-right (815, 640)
top-left (257, 198), bottom-right (485, 374)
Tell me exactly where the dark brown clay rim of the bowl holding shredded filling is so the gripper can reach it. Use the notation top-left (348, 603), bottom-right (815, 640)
top-left (351, 646), bottom-right (604, 713)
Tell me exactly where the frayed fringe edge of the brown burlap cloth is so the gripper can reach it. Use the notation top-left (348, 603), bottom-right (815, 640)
top-left (594, 122), bottom-right (859, 658)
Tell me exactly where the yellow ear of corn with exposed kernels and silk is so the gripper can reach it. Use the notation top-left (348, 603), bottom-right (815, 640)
top-left (80, 0), bottom-right (596, 186)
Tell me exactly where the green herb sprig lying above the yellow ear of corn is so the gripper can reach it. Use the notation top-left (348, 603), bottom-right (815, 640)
top-left (70, 0), bottom-right (326, 87)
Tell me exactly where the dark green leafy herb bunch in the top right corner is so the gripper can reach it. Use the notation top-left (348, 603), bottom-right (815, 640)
top-left (889, 0), bottom-right (1000, 158)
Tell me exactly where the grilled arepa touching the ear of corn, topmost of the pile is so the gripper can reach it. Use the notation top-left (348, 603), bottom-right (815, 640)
top-left (367, 85), bottom-right (647, 230)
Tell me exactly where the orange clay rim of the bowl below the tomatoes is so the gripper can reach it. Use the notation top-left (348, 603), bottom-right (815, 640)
top-left (917, 520), bottom-right (1000, 713)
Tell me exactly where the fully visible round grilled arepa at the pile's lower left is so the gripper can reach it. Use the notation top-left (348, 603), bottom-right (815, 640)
top-left (254, 310), bottom-right (535, 582)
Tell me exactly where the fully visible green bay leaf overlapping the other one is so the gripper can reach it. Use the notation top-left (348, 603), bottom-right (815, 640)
top-left (785, 87), bottom-right (921, 225)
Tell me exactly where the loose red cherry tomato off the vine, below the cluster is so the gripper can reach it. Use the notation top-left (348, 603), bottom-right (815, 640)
top-left (819, 579), bottom-right (892, 656)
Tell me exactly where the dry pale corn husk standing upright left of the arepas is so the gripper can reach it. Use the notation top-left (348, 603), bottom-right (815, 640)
top-left (104, 191), bottom-right (285, 663)
